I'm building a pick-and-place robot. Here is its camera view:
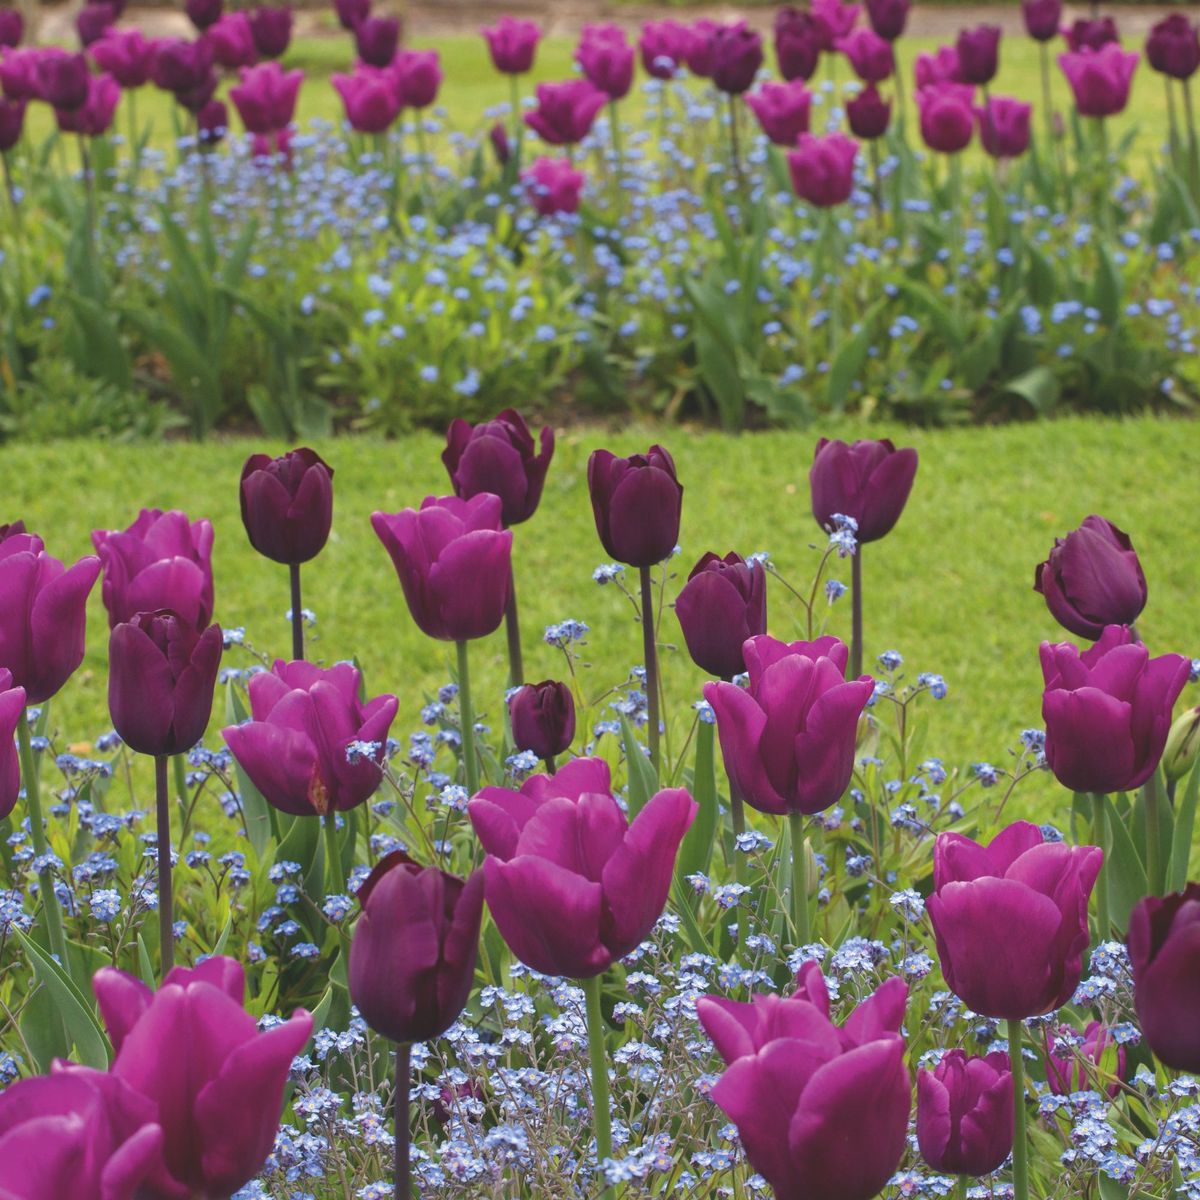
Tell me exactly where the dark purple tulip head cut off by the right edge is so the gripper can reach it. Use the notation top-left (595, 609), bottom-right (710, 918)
top-left (1128, 883), bottom-right (1200, 1074)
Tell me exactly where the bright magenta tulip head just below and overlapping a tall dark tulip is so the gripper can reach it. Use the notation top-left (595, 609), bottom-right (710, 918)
top-left (371, 492), bottom-right (512, 642)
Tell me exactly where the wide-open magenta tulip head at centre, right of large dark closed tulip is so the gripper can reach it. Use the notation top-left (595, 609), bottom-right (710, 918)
top-left (467, 758), bottom-right (696, 979)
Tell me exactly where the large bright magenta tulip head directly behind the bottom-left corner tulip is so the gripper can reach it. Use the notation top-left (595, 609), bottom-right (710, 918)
top-left (95, 956), bottom-right (312, 1196)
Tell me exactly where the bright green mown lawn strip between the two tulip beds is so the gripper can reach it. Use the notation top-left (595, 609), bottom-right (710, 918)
top-left (11, 418), bottom-right (1200, 830)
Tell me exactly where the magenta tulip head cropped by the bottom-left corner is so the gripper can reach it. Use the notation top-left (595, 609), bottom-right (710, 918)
top-left (0, 1061), bottom-right (168, 1200)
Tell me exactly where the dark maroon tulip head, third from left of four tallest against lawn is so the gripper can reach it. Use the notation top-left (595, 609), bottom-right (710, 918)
top-left (588, 445), bottom-right (683, 566)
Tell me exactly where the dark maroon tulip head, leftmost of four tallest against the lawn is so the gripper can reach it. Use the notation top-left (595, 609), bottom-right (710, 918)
top-left (240, 446), bottom-right (334, 564)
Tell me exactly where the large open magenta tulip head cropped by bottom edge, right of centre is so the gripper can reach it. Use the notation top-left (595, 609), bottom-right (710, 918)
top-left (696, 962), bottom-right (912, 1200)
